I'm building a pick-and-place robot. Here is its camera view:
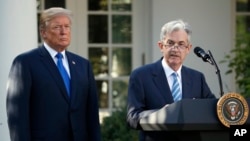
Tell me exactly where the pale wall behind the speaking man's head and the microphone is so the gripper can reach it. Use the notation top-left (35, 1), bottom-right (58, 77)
top-left (152, 0), bottom-right (235, 97)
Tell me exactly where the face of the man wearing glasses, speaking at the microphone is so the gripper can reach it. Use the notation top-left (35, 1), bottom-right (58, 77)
top-left (158, 30), bottom-right (192, 71)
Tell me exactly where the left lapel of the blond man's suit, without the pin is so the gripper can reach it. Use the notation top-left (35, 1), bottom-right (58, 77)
top-left (39, 46), bottom-right (70, 103)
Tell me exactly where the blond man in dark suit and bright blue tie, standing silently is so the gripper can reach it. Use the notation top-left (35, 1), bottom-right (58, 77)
top-left (7, 8), bottom-right (101, 141)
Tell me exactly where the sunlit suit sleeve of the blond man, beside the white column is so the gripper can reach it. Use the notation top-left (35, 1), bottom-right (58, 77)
top-left (6, 57), bottom-right (31, 141)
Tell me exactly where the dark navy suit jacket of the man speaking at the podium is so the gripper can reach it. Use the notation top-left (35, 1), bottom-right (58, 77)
top-left (127, 59), bottom-right (215, 141)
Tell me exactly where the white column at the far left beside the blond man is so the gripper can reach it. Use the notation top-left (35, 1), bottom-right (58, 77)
top-left (0, 0), bottom-right (38, 141)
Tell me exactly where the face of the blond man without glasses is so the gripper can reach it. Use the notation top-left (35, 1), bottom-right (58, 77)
top-left (42, 15), bottom-right (71, 51)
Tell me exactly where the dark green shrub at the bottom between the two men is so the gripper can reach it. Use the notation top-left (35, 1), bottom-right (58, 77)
top-left (101, 108), bottom-right (138, 141)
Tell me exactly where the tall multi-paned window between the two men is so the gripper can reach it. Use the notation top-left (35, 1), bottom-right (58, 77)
top-left (88, 0), bottom-right (132, 118)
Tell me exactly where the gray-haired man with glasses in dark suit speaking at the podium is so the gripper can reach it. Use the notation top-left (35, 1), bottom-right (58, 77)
top-left (127, 20), bottom-right (215, 141)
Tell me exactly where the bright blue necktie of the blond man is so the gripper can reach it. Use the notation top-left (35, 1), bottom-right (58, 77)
top-left (56, 53), bottom-right (70, 96)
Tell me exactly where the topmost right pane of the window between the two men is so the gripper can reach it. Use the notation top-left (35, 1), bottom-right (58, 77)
top-left (112, 0), bottom-right (131, 11)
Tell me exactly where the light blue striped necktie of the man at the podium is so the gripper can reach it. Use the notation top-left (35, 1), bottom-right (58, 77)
top-left (172, 73), bottom-right (182, 101)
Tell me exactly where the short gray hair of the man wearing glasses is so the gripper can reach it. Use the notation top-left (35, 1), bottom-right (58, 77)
top-left (160, 20), bottom-right (192, 42)
